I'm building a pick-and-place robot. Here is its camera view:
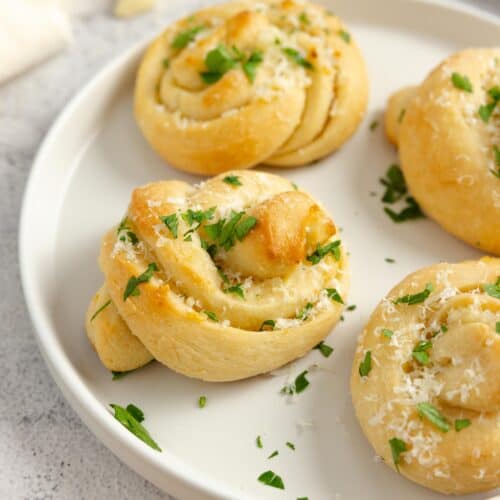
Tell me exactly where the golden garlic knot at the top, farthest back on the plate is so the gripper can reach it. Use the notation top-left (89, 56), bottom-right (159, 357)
top-left (135, 0), bottom-right (368, 175)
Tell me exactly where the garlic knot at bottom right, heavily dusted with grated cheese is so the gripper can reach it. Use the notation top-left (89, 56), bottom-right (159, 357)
top-left (351, 257), bottom-right (500, 495)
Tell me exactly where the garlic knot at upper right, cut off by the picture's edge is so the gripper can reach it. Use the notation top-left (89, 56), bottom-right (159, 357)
top-left (385, 49), bottom-right (500, 255)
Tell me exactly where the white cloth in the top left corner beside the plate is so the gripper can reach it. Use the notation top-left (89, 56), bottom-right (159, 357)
top-left (0, 0), bottom-right (72, 83)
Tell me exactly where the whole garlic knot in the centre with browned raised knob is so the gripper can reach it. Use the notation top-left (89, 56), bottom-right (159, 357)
top-left (87, 171), bottom-right (348, 381)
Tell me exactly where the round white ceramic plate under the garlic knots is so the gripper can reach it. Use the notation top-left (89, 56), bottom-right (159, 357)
top-left (20, 0), bottom-right (500, 500)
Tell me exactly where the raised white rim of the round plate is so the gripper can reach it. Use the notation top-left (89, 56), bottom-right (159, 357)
top-left (17, 0), bottom-right (500, 499)
